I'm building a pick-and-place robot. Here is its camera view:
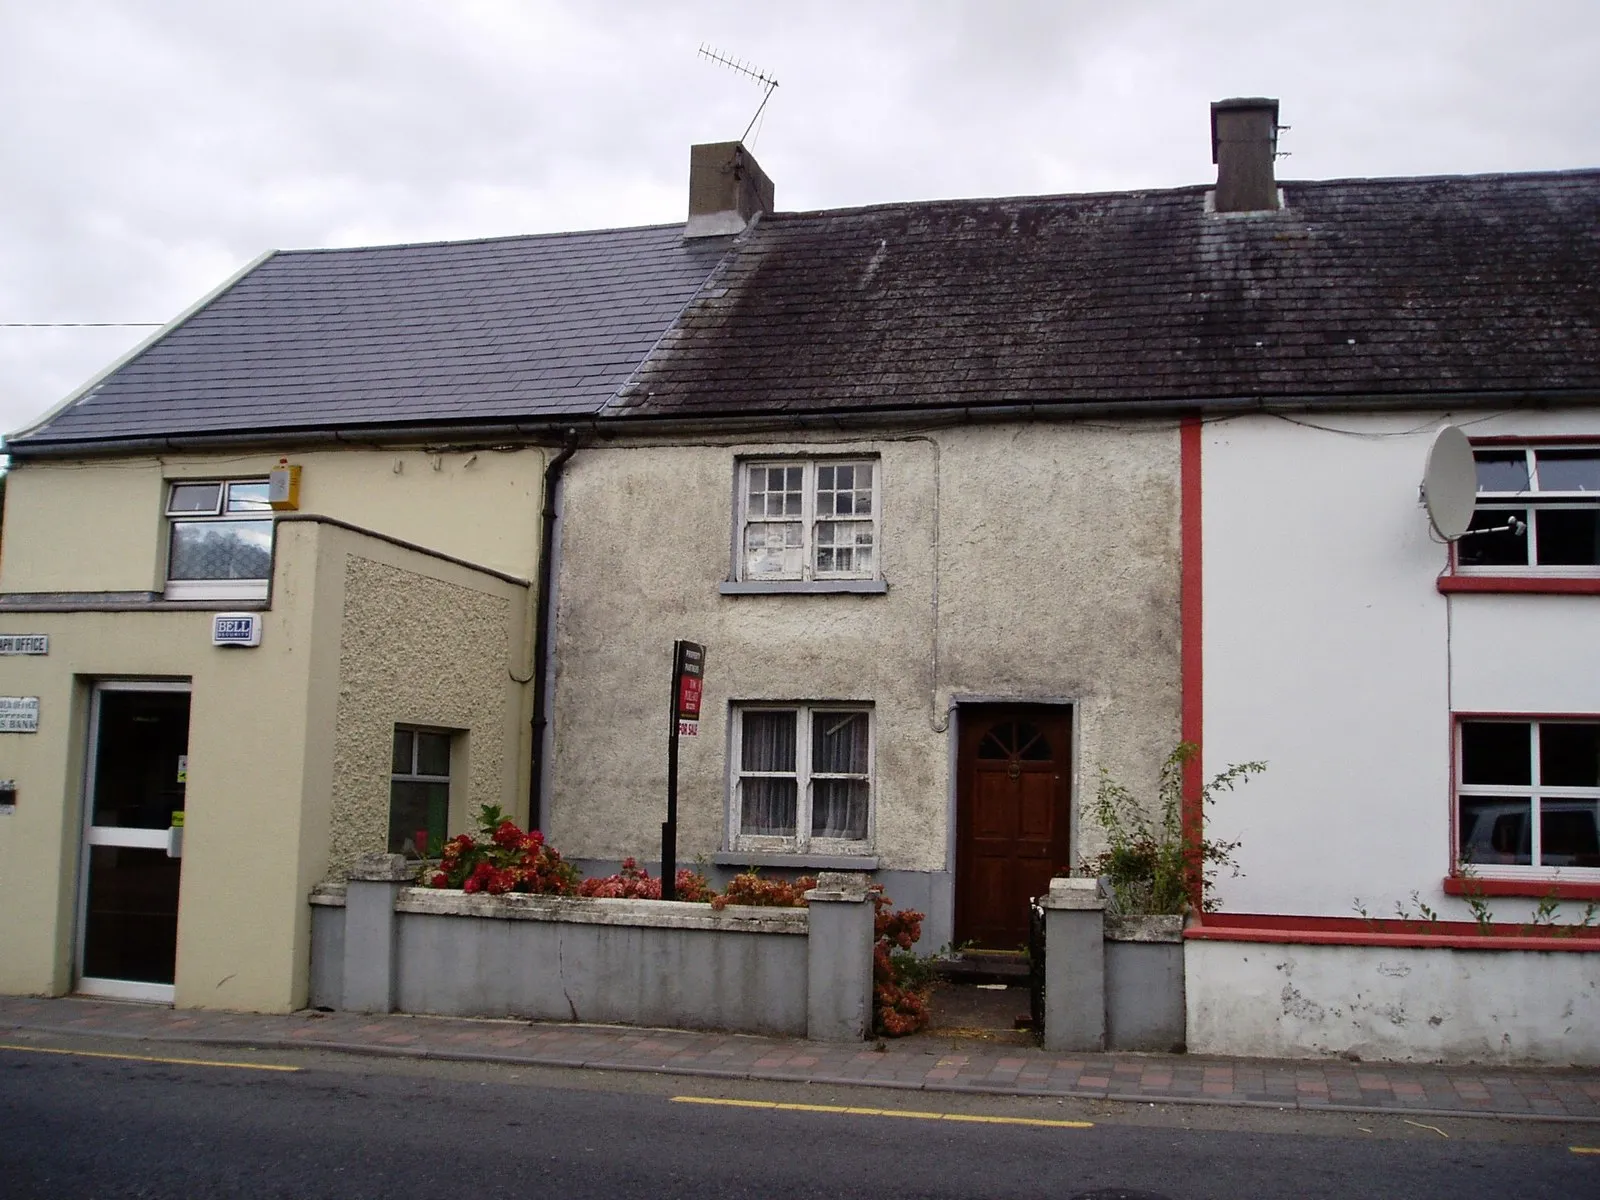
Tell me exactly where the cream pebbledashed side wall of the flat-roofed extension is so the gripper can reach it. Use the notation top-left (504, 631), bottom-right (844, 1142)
top-left (328, 555), bottom-right (518, 877)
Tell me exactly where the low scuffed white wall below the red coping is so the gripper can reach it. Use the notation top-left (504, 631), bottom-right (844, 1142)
top-left (1184, 941), bottom-right (1600, 1066)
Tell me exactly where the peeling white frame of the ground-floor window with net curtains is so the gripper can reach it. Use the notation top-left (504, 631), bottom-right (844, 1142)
top-left (728, 701), bottom-right (878, 854)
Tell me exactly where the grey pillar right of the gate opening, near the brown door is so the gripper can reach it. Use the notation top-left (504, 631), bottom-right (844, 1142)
top-left (1045, 878), bottom-right (1106, 1050)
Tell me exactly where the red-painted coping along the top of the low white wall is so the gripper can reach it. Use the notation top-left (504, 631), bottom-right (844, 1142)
top-left (1184, 912), bottom-right (1600, 952)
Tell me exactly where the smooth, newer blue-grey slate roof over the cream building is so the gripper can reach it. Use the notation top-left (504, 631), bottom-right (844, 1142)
top-left (11, 224), bottom-right (728, 453)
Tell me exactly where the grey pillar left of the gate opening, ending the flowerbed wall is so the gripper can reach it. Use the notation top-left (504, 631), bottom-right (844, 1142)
top-left (805, 870), bottom-right (877, 1042)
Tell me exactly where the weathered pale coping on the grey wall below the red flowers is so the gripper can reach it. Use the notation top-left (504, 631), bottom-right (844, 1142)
top-left (395, 888), bottom-right (811, 936)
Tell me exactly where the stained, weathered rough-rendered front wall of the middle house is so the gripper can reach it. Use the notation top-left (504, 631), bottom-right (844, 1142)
top-left (549, 424), bottom-right (1179, 872)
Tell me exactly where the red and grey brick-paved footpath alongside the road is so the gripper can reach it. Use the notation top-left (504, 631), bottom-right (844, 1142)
top-left (0, 997), bottom-right (1600, 1123)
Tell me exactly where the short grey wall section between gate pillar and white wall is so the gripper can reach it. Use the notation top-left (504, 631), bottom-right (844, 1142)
top-left (1106, 917), bottom-right (1187, 1051)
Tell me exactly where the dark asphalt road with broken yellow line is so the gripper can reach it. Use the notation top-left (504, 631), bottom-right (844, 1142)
top-left (0, 1042), bottom-right (1600, 1200)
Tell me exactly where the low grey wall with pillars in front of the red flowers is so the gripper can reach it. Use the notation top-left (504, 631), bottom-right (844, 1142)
top-left (310, 856), bottom-right (872, 1040)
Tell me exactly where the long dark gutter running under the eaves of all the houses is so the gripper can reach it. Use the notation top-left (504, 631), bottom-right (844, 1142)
top-left (5, 387), bottom-right (1597, 461)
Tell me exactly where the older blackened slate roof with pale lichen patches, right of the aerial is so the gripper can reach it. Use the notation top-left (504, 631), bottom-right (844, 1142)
top-left (608, 171), bottom-right (1600, 416)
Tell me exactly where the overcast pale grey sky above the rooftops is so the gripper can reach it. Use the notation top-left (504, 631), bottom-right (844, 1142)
top-left (0, 0), bottom-right (1600, 441)
